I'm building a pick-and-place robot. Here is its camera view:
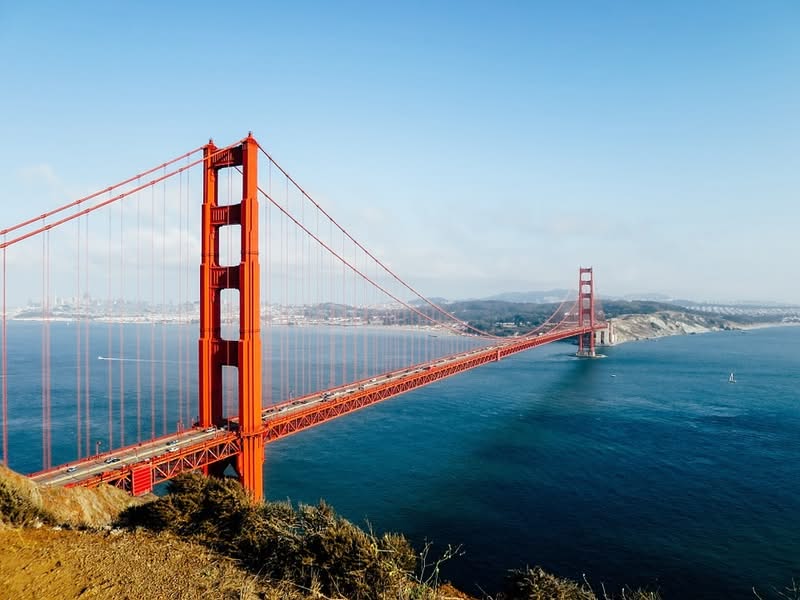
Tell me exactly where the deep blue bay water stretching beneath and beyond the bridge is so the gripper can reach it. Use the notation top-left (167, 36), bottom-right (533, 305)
top-left (1, 323), bottom-right (800, 600)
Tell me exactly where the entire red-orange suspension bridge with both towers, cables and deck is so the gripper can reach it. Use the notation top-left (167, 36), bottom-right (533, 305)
top-left (0, 135), bottom-right (605, 499)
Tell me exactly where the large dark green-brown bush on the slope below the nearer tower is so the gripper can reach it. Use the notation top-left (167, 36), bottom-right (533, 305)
top-left (120, 474), bottom-right (425, 600)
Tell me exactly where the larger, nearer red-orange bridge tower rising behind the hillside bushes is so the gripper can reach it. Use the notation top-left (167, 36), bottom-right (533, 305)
top-left (199, 135), bottom-right (264, 500)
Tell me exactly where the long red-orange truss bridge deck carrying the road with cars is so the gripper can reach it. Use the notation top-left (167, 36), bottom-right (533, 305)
top-left (30, 324), bottom-right (605, 494)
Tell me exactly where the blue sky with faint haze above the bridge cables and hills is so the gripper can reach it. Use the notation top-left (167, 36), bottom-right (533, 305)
top-left (0, 0), bottom-right (800, 303)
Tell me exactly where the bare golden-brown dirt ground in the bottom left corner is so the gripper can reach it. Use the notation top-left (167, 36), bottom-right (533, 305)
top-left (0, 527), bottom-right (274, 600)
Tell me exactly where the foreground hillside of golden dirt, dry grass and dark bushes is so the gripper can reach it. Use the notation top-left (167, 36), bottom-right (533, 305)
top-left (0, 468), bottom-right (658, 600)
